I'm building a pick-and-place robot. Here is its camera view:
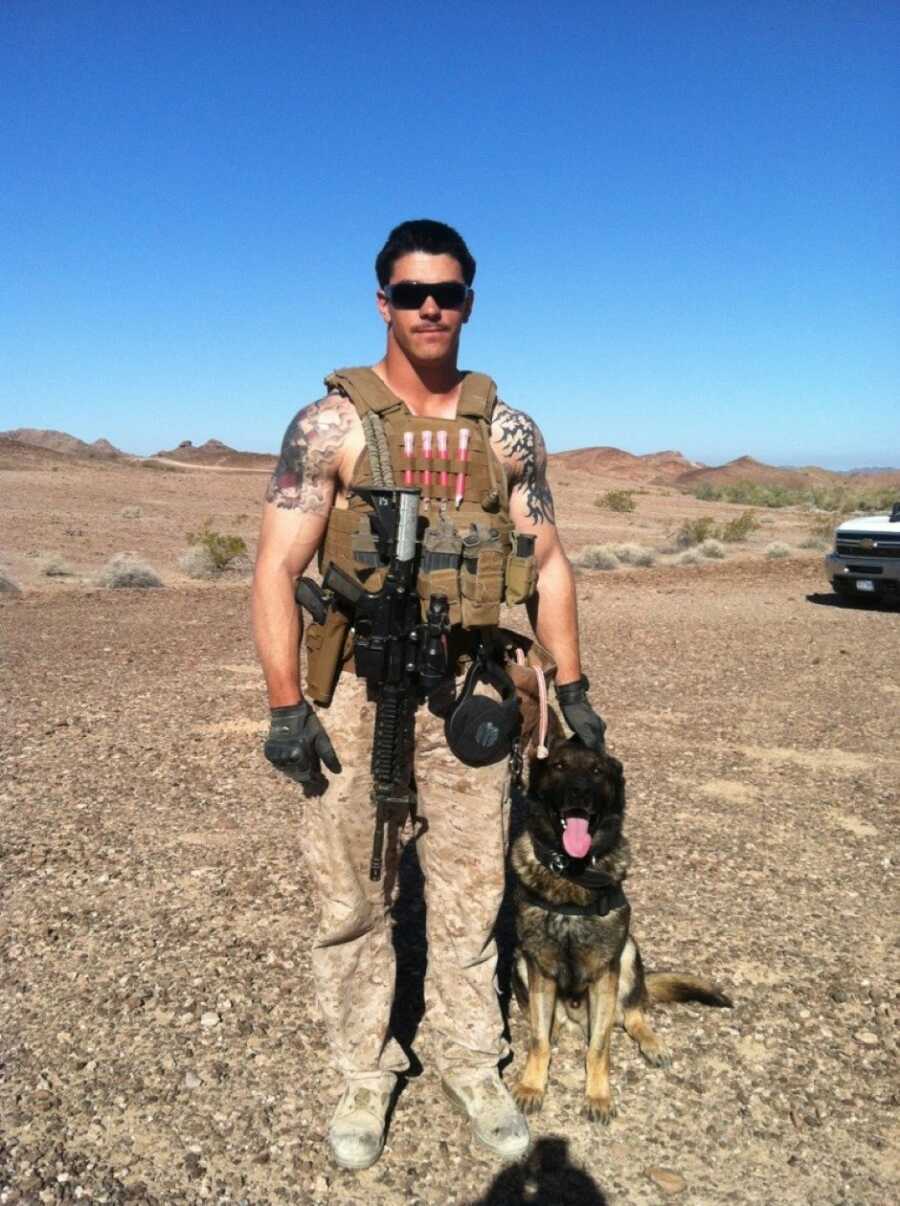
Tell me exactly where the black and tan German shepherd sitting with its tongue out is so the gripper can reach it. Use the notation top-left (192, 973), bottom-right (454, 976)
top-left (512, 671), bottom-right (732, 1123)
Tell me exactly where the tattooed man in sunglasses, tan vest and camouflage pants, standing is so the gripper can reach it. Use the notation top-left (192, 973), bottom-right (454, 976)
top-left (253, 219), bottom-right (603, 1169)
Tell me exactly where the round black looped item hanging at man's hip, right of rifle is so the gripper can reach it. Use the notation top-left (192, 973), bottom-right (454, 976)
top-left (444, 658), bottom-right (520, 766)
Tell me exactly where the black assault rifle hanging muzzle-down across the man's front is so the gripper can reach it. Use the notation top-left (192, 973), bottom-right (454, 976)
top-left (297, 486), bottom-right (451, 880)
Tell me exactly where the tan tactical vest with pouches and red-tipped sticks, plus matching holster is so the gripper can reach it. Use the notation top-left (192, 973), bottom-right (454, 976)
top-left (305, 368), bottom-right (537, 703)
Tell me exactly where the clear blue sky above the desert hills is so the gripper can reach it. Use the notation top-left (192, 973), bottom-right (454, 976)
top-left (0, 0), bottom-right (900, 468)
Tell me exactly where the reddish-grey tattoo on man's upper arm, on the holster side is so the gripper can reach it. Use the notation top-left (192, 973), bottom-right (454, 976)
top-left (265, 393), bottom-right (355, 515)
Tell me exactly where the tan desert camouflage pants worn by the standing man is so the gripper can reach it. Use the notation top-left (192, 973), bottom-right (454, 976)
top-left (300, 674), bottom-right (509, 1079)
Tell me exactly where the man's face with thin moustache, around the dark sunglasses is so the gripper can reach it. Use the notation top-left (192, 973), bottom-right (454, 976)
top-left (378, 251), bottom-right (473, 364)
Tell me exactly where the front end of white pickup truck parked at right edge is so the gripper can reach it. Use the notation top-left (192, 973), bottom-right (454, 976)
top-left (825, 503), bottom-right (900, 603)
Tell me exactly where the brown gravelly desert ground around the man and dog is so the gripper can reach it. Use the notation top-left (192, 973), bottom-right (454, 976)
top-left (0, 447), bottom-right (900, 1206)
